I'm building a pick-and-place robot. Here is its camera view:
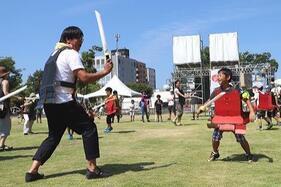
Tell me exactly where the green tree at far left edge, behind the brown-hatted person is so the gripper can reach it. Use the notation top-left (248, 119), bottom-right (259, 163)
top-left (0, 57), bottom-right (22, 91)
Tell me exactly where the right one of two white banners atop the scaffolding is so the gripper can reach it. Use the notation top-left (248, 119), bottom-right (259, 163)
top-left (209, 32), bottom-right (239, 62)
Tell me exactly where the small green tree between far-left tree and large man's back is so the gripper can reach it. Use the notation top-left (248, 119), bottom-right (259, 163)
top-left (25, 70), bottom-right (43, 95)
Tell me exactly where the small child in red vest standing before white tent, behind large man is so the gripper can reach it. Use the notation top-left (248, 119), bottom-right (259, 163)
top-left (104, 87), bottom-right (116, 133)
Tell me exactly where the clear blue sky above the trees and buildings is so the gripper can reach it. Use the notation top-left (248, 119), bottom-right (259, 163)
top-left (0, 0), bottom-right (281, 88)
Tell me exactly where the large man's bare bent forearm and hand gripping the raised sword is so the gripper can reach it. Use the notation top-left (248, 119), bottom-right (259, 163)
top-left (73, 60), bottom-right (113, 83)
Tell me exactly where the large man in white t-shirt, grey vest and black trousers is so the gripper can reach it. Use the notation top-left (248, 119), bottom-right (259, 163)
top-left (25, 26), bottom-right (113, 182)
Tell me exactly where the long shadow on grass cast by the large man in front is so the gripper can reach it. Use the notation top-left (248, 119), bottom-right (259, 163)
top-left (45, 162), bottom-right (176, 179)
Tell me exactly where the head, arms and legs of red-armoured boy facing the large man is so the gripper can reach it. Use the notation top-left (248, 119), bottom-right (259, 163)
top-left (199, 68), bottom-right (255, 162)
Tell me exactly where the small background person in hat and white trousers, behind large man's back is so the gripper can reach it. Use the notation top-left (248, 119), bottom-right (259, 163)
top-left (22, 93), bottom-right (37, 135)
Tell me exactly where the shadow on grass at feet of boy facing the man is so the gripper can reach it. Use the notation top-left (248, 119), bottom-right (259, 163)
top-left (221, 154), bottom-right (273, 163)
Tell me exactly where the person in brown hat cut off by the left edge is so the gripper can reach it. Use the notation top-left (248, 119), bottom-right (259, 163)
top-left (0, 66), bottom-right (13, 151)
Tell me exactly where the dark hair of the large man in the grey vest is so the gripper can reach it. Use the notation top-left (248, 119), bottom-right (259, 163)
top-left (60, 26), bottom-right (84, 43)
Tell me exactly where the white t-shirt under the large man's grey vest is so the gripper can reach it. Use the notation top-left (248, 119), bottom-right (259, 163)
top-left (55, 49), bottom-right (84, 103)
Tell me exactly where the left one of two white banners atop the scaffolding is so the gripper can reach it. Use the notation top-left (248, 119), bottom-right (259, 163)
top-left (173, 35), bottom-right (201, 65)
